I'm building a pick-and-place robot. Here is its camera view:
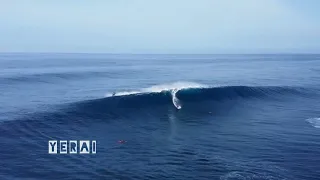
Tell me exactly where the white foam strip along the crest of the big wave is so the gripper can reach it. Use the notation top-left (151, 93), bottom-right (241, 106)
top-left (105, 82), bottom-right (208, 97)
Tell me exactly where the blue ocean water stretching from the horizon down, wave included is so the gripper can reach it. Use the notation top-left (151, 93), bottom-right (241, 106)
top-left (0, 53), bottom-right (320, 180)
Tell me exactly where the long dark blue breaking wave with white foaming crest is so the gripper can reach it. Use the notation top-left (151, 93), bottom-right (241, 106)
top-left (6, 82), bottom-right (310, 122)
